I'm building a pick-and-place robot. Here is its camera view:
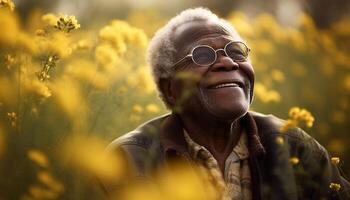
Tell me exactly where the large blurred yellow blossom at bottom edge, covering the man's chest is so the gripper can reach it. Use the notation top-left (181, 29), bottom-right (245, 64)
top-left (115, 163), bottom-right (220, 200)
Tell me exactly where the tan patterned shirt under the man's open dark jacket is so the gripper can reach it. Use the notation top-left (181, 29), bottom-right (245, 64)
top-left (184, 130), bottom-right (252, 200)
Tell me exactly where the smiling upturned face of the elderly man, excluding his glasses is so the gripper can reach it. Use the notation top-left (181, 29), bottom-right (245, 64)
top-left (163, 21), bottom-right (254, 120)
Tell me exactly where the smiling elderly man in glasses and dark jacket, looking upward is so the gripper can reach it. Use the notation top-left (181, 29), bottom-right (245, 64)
top-left (104, 8), bottom-right (350, 199)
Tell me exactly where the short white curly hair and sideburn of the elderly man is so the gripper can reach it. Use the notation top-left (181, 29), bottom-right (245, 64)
top-left (147, 7), bottom-right (239, 106)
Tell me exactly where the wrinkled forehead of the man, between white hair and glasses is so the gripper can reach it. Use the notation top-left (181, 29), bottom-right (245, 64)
top-left (172, 20), bottom-right (242, 50)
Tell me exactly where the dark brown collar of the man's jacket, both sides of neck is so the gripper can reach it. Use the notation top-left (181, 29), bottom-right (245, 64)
top-left (160, 112), bottom-right (265, 156)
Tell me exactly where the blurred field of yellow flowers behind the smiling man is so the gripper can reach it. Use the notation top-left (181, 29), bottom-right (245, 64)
top-left (0, 0), bottom-right (350, 199)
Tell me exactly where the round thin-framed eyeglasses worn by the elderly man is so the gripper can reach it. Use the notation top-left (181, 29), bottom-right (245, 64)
top-left (173, 41), bottom-right (250, 68)
